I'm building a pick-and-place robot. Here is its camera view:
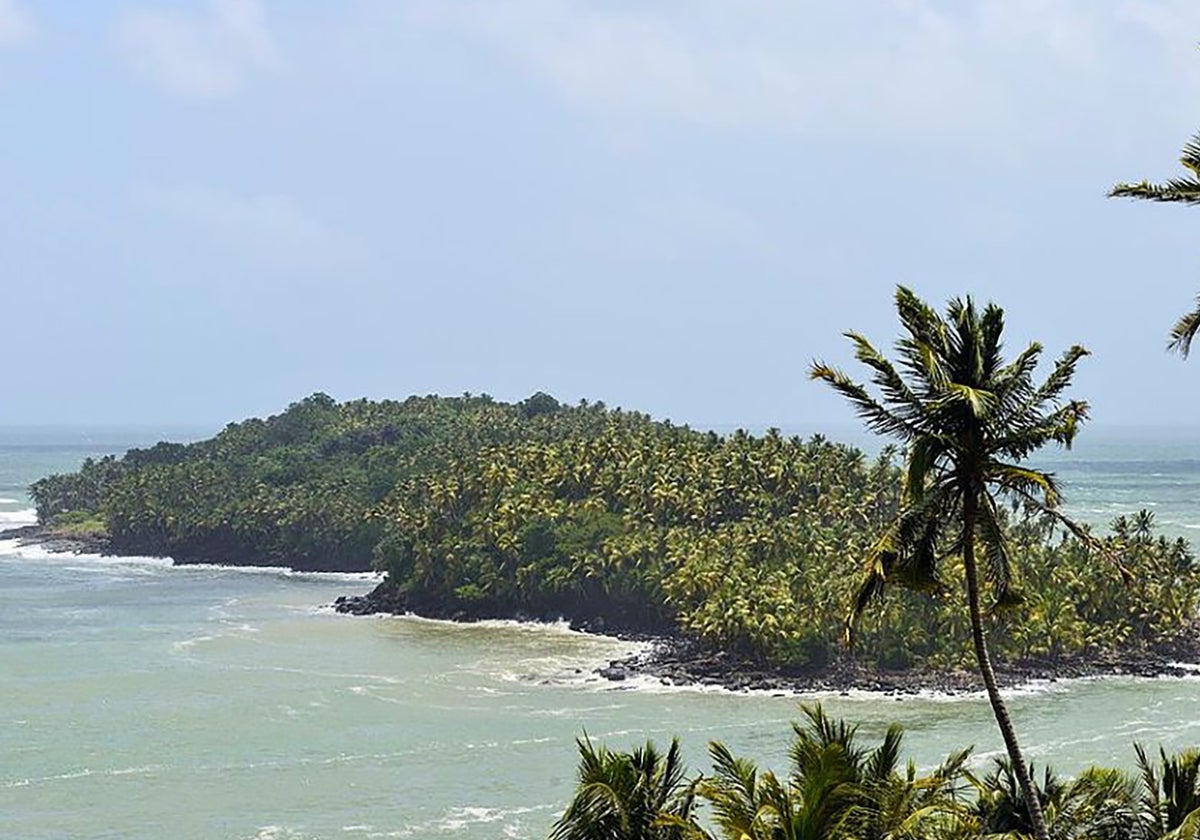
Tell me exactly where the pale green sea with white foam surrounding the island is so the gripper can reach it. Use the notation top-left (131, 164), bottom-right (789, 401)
top-left (7, 430), bottom-right (1200, 840)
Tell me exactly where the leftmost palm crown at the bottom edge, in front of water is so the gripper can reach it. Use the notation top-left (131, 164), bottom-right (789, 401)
top-left (550, 736), bottom-right (700, 840)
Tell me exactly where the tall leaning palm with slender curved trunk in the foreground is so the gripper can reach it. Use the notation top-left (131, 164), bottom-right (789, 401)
top-left (811, 287), bottom-right (1088, 840)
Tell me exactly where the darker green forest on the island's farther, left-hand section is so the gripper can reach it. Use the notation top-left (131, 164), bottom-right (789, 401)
top-left (30, 394), bottom-right (624, 571)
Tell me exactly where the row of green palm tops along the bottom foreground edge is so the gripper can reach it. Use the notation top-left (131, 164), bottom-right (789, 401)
top-left (551, 707), bottom-right (1200, 840)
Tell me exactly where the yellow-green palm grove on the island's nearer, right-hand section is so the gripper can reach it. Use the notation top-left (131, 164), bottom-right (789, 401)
top-left (377, 398), bottom-right (1200, 668)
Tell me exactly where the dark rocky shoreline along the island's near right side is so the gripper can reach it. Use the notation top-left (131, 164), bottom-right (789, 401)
top-left (334, 583), bottom-right (1200, 696)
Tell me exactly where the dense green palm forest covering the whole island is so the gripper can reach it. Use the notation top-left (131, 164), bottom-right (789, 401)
top-left (25, 395), bottom-right (1200, 668)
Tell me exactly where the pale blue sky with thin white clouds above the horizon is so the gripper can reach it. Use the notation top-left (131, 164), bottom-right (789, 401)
top-left (7, 0), bottom-right (1200, 430)
